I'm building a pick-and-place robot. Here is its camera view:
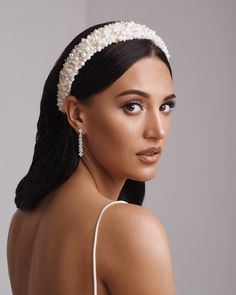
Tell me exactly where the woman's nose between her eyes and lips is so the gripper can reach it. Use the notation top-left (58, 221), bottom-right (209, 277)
top-left (144, 110), bottom-right (168, 139)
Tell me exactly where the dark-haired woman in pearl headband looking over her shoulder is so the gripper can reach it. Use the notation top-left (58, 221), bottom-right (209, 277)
top-left (7, 21), bottom-right (175, 295)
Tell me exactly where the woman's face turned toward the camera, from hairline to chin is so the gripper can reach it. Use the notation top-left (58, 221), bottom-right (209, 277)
top-left (81, 57), bottom-right (174, 181)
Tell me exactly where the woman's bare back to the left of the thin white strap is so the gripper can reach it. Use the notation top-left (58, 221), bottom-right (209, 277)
top-left (7, 194), bottom-right (118, 295)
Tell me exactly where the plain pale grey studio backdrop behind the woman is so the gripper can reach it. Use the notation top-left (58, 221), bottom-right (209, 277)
top-left (0, 0), bottom-right (236, 295)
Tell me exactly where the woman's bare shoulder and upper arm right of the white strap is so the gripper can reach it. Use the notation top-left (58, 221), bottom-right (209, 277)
top-left (100, 204), bottom-right (176, 295)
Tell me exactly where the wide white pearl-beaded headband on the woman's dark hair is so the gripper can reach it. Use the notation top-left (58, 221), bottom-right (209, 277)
top-left (57, 21), bottom-right (170, 113)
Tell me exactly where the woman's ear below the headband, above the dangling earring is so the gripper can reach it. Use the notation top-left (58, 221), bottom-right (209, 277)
top-left (64, 95), bottom-right (86, 133)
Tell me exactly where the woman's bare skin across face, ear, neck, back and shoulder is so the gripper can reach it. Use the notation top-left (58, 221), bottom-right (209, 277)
top-left (7, 57), bottom-right (176, 295)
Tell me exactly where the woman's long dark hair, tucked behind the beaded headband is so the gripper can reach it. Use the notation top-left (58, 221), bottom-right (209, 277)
top-left (15, 21), bottom-right (172, 211)
